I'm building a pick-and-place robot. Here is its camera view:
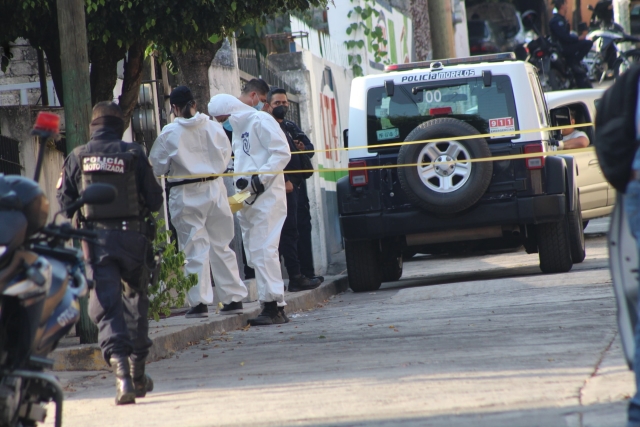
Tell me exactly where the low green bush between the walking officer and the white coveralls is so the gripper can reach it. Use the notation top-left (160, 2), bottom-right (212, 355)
top-left (149, 219), bottom-right (198, 322)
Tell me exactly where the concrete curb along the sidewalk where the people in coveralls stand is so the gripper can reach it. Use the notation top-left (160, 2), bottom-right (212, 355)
top-left (49, 276), bottom-right (349, 371)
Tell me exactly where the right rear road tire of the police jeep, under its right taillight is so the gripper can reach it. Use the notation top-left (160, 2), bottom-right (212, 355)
top-left (536, 217), bottom-right (573, 273)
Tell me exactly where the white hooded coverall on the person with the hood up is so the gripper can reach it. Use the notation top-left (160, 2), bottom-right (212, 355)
top-left (209, 94), bottom-right (291, 306)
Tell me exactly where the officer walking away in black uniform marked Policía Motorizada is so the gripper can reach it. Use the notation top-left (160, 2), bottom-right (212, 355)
top-left (58, 102), bottom-right (162, 405)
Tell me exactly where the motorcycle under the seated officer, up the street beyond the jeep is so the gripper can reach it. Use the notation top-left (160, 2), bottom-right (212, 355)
top-left (522, 10), bottom-right (590, 92)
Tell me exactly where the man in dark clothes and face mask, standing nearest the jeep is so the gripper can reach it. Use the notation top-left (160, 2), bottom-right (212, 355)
top-left (267, 88), bottom-right (322, 292)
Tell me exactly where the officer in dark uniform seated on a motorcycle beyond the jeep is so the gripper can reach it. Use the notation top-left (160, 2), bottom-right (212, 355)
top-left (549, 0), bottom-right (593, 88)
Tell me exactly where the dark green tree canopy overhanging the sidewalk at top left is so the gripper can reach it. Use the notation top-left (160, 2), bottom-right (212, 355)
top-left (0, 0), bottom-right (327, 126)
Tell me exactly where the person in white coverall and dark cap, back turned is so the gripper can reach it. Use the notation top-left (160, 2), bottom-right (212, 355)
top-left (149, 86), bottom-right (247, 318)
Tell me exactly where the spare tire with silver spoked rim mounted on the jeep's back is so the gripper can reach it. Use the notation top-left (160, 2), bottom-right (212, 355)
top-left (398, 118), bottom-right (493, 214)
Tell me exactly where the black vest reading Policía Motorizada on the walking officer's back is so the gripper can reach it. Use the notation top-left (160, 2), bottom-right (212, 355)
top-left (80, 151), bottom-right (141, 221)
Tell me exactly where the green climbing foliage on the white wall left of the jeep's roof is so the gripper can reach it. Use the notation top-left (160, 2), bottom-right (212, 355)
top-left (344, 0), bottom-right (389, 77)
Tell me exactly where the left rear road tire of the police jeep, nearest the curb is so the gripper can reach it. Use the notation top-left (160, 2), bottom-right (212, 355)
top-left (344, 240), bottom-right (382, 292)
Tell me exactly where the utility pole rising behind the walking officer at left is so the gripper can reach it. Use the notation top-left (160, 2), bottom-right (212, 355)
top-left (57, 0), bottom-right (98, 344)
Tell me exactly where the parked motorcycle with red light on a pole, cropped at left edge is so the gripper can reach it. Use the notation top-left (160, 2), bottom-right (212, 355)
top-left (0, 113), bottom-right (116, 427)
